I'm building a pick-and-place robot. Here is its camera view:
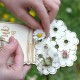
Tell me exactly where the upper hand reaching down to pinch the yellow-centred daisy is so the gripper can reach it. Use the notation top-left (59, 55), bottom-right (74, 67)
top-left (1, 0), bottom-right (60, 37)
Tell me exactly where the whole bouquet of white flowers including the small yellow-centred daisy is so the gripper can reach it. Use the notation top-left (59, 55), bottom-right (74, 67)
top-left (33, 20), bottom-right (79, 75)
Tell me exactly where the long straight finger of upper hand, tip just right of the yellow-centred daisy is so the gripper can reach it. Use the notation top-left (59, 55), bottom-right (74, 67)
top-left (31, 2), bottom-right (50, 37)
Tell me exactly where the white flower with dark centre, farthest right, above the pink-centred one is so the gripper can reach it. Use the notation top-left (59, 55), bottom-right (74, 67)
top-left (56, 30), bottom-right (79, 51)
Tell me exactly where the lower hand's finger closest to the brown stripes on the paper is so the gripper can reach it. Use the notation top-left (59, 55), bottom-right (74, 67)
top-left (13, 39), bottom-right (24, 68)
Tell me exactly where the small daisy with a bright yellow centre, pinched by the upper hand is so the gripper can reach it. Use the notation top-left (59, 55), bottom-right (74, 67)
top-left (33, 29), bottom-right (46, 41)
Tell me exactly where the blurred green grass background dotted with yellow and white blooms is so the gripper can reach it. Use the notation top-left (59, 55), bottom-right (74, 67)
top-left (0, 0), bottom-right (80, 80)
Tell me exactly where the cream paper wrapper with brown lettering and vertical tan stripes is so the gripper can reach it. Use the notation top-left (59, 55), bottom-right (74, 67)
top-left (0, 22), bottom-right (35, 64)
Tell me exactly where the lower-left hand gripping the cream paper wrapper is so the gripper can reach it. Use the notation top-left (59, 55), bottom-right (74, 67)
top-left (0, 37), bottom-right (30, 80)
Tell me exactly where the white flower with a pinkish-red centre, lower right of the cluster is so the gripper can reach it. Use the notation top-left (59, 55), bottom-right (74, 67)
top-left (58, 50), bottom-right (77, 67)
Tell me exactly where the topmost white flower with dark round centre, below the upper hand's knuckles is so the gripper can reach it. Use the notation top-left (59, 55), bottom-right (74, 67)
top-left (50, 20), bottom-right (67, 39)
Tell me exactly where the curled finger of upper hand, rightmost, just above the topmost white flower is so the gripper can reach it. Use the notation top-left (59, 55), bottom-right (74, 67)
top-left (43, 0), bottom-right (59, 22)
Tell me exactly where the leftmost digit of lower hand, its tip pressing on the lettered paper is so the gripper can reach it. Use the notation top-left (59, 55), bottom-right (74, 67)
top-left (0, 37), bottom-right (18, 63)
